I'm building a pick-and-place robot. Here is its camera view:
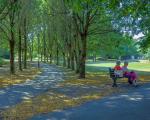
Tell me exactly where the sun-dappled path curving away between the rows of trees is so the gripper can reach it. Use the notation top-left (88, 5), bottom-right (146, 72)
top-left (0, 63), bottom-right (64, 110)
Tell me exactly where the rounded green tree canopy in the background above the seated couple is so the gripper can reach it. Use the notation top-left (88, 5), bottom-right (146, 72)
top-left (88, 33), bottom-right (138, 58)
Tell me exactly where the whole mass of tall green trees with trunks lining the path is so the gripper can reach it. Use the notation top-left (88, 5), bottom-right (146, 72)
top-left (0, 0), bottom-right (150, 78)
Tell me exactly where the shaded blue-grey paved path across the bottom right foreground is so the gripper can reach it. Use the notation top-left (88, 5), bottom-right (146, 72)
top-left (31, 84), bottom-right (150, 120)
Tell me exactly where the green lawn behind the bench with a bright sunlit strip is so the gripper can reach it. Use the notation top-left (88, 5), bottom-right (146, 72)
top-left (86, 61), bottom-right (150, 82)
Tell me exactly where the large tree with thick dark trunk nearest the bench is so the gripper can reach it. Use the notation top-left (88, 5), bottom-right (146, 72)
top-left (64, 0), bottom-right (117, 78)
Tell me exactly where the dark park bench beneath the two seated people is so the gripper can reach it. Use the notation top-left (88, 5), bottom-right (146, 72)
top-left (109, 68), bottom-right (124, 87)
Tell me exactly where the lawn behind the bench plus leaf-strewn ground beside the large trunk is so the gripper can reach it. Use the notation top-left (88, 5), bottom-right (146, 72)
top-left (60, 61), bottom-right (150, 86)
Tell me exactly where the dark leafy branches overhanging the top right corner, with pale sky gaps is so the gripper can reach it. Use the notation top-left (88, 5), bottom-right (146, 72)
top-left (109, 0), bottom-right (150, 35)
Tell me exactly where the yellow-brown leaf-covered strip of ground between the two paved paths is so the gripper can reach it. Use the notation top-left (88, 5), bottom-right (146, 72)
top-left (2, 88), bottom-right (125, 120)
